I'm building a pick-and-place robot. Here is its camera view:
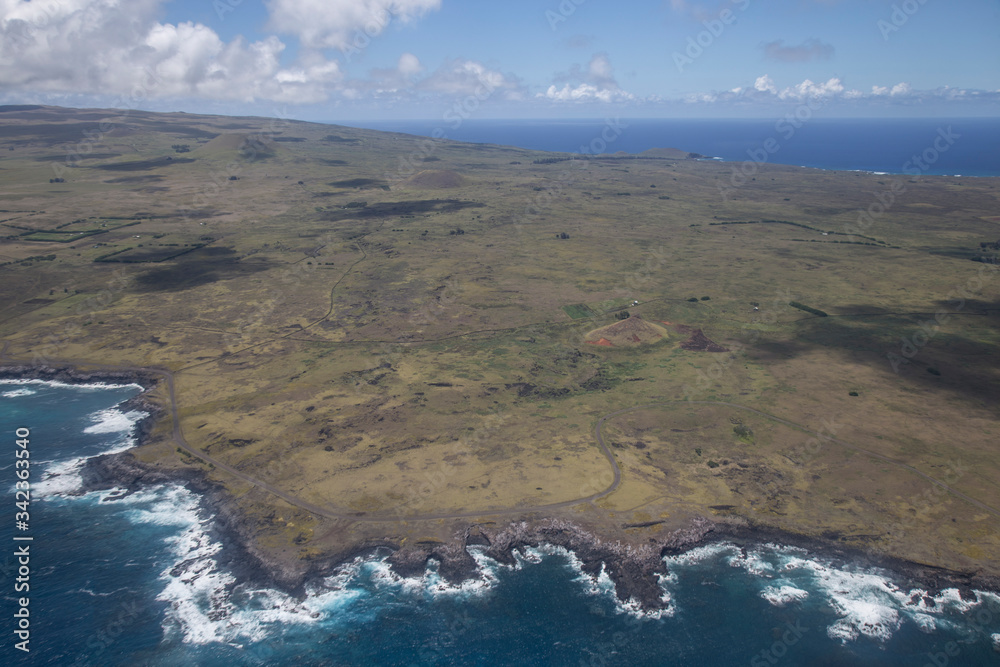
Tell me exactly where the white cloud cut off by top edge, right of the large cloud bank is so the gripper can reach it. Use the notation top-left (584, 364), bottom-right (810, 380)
top-left (266, 0), bottom-right (441, 49)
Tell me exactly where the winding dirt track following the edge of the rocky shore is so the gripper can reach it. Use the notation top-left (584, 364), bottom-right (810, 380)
top-left (0, 341), bottom-right (1000, 523)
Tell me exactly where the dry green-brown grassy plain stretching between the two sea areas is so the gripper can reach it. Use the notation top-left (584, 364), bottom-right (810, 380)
top-left (0, 107), bottom-right (1000, 574)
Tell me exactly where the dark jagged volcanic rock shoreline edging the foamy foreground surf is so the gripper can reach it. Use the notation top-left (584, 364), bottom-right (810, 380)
top-left (7, 366), bottom-right (1000, 611)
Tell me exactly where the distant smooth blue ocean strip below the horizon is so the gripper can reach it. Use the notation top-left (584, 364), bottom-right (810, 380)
top-left (338, 118), bottom-right (1000, 176)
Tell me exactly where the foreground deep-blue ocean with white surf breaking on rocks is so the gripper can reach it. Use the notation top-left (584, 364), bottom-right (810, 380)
top-left (0, 382), bottom-right (1000, 667)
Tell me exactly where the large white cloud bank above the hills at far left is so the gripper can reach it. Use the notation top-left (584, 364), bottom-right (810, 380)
top-left (0, 0), bottom-right (342, 103)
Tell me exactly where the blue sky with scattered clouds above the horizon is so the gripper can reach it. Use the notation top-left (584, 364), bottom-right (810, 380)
top-left (0, 0), bottom-right (1000, 120)
